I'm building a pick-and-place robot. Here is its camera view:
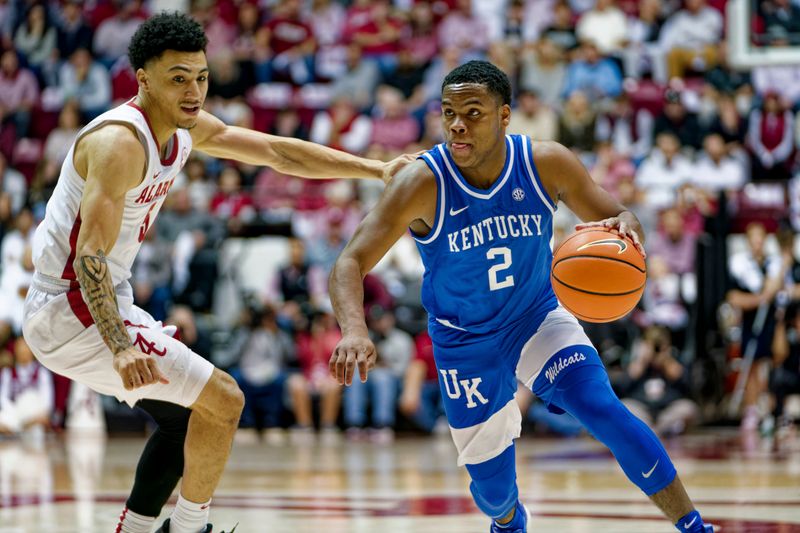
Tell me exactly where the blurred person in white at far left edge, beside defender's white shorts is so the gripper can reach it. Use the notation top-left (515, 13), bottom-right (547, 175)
top-left (0, 336), bottom-right (54, 438)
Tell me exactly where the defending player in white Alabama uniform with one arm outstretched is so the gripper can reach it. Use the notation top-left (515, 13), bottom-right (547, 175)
top-left (23, 13), bottom-right (411, 533)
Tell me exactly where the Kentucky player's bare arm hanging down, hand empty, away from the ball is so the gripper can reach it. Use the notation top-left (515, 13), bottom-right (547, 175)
top-left (328, 161), bottom-right (436, 385)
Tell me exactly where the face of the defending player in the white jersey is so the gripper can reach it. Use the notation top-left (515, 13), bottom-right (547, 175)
top-left (140, 50), bottom-right (208, 129)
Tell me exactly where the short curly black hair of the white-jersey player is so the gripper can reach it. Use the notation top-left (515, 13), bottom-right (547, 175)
top-left (128, 11), bottom-right (208, 71)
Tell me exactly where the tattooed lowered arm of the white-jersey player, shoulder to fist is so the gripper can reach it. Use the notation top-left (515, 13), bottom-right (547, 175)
top-left (72, 124), bottom-right (166, 389)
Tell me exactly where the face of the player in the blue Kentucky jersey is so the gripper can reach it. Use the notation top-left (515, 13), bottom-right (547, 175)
top-left (442, 83), bottom-right (511, 168)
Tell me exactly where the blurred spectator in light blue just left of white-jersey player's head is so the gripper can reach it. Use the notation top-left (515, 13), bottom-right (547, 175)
top-left (59, 48), bottom-right (111, 120)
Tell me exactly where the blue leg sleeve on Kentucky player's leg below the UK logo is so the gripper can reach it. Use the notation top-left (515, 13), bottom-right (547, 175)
top-left (466, 444), bottom-right (519, 518)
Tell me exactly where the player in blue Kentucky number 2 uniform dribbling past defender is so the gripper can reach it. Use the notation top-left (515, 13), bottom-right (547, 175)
top-left (330, 61), bottom-right (713, 532)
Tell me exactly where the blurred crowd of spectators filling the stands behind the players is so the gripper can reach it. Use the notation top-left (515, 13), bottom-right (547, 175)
top-left (0, 0), bottom-right (800, 442)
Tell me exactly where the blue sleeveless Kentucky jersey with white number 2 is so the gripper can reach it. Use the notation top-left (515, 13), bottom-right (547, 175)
top-left (414, 135), bottom-right (557, 342)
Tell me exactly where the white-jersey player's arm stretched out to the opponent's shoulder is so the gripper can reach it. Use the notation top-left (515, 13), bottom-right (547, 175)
top-left (190, 111), bottom-right (416, 182)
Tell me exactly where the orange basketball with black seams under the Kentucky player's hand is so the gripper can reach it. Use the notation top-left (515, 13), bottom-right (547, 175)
top-left (550, 228), bottom-right (647, 322)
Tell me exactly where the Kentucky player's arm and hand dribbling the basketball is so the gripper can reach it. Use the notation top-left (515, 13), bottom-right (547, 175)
top-left (533, 142), bottom-right (645, 255)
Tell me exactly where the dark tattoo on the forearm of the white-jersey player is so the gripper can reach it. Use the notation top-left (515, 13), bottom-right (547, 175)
top-left (75, 250), bottom-right (131, 354)
